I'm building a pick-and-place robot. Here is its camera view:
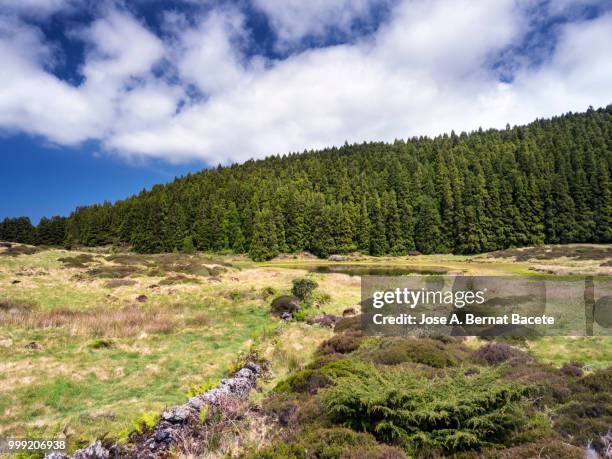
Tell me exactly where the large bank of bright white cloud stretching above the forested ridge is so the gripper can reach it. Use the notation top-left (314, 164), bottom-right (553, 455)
top-left (0, 0), bottom-right (612, 163)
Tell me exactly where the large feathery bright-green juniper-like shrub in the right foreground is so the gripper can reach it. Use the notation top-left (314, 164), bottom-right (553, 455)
top-left (319, 366), bottom-right (527, 452)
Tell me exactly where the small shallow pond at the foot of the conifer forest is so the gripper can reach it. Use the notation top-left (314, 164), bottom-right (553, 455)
top-left (276, 264), bottom-right (448, 276)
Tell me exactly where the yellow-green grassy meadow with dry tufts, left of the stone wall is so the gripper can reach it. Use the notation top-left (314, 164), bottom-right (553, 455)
top-left (0, 245), bottom-right (612, 452)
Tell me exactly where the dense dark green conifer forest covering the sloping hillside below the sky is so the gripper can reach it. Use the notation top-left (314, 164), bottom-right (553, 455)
top-left (0, 105), bottom-right (612, 260)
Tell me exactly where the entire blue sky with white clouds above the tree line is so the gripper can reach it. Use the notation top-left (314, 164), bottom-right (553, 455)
top-left (0, 0), bottom-right (612, 222)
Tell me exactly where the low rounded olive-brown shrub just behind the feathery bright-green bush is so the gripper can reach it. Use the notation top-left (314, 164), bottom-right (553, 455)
top-left (359, 338), bottom-right (467, 368)
